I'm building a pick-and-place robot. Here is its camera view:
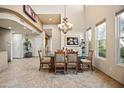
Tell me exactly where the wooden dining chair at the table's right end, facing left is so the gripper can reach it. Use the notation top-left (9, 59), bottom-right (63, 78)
top-left (81, 50), bottom-right (94, 71)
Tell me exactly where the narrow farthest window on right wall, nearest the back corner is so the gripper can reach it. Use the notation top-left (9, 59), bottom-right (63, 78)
top-left (85, 28), bottom-right (92, 54)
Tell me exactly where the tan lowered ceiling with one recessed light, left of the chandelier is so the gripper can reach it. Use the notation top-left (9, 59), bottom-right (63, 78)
top-left (38, 14), bottom-right (61, 24)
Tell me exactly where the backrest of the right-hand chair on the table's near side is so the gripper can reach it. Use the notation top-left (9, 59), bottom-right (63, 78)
top-left (67, 51), bottom-right (78, 62)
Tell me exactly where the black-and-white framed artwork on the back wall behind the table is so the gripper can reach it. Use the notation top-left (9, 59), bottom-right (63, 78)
top-left (65, 35), bottom-right (80, 46)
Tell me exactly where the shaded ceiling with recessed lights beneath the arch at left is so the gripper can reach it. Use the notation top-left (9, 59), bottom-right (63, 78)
top-left (0, 19), bottom-right (37, 34)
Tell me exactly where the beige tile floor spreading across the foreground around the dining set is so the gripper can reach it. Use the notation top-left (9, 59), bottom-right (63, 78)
top-left (0, 58), bottom-right (124, 88)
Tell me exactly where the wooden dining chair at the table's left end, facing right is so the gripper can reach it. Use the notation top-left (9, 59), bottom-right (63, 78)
top-left (38, 50), bottom-right (51, 71)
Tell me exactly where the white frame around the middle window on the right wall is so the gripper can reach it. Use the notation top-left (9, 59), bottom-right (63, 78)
top-left (95, 19), bottom-right (107, 61)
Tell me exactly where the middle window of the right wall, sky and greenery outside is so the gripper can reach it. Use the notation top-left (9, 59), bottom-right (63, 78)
top-left (96, 22), bottom-right (106, 58)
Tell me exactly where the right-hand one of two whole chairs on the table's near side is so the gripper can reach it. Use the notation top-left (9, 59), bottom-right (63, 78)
top-left (67, 51), bottom-right (78, 74)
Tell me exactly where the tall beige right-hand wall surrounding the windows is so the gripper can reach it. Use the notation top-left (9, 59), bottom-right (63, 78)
top-left (84, 6), bottom-right (124, 84)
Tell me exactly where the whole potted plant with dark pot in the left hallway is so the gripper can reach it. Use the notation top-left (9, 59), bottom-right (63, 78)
top-left (24, 36), bottom-right (32, 58)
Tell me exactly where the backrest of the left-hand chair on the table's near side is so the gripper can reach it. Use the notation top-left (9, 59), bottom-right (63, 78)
top-left (55, 51), bottom-right (65, 62)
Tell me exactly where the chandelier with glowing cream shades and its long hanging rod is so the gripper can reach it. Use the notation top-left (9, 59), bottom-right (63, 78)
top-left (58, 6), bottom-right (72, 34)
